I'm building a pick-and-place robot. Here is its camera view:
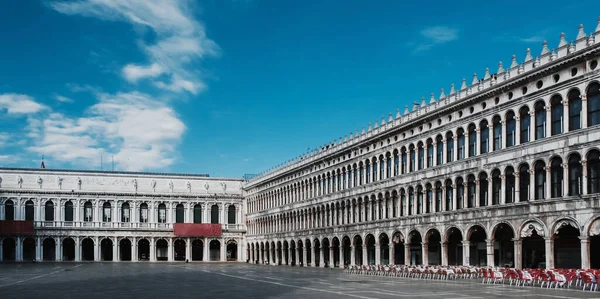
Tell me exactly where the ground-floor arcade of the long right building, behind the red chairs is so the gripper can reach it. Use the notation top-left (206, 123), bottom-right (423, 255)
top-left (246, 217), bottom-right (600, 268)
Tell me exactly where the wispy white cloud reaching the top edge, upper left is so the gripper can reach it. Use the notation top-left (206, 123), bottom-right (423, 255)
top-left (50, 0), bottom-right (220, 94)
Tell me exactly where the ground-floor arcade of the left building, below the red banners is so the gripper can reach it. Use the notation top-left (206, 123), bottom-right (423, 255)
top-left (0, 236), bottom-right (241, 262)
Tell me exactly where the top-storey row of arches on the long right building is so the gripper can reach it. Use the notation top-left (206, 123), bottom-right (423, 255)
top-left (249, 81), bottom-right (600, 213)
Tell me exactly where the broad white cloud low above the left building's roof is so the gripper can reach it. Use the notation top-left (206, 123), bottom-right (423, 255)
top-left (27, 92), bottom-right (185, 171)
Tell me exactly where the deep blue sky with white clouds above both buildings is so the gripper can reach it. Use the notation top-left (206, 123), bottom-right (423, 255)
top-left (0, 0), bottom-right (598, 177)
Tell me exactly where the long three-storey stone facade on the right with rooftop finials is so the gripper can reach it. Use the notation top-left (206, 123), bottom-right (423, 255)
top-left (244, 20), bottom-right (600, 268)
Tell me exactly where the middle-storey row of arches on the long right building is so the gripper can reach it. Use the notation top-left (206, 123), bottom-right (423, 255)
top-left (248, 148), bottom-right (600, 235)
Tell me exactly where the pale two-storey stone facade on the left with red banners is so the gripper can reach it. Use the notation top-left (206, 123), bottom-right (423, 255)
top-left (0, 168), bottom-right (246, 261)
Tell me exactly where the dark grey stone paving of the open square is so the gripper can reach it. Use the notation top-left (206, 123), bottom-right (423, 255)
top-left (0, 263), bottom-right (600, 299)
